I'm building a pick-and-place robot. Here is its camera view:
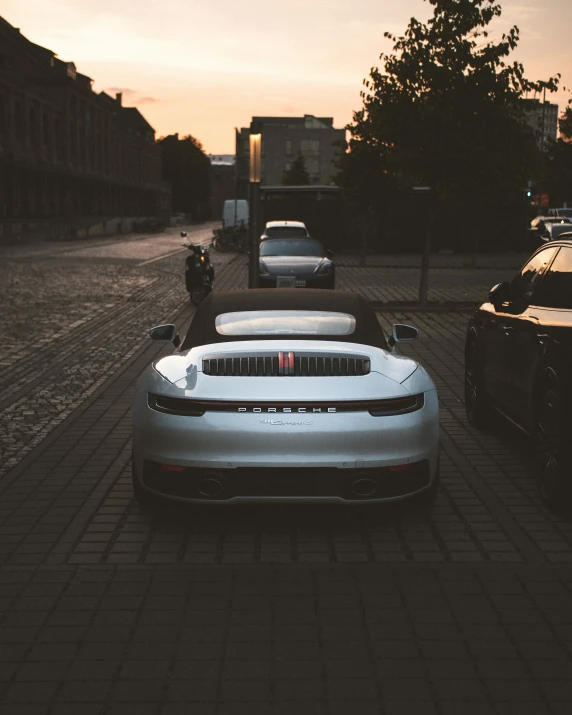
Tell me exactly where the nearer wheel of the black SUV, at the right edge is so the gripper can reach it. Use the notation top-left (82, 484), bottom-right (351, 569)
top-left (534, 387), bottom-right (572, 509)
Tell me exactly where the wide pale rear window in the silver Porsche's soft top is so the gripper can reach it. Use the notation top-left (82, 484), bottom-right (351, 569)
top-left (215, 310), bottom-right (356, 336)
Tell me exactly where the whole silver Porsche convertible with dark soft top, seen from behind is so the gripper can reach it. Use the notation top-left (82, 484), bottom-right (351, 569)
top-left (133, 289), bottom-right (439, 504)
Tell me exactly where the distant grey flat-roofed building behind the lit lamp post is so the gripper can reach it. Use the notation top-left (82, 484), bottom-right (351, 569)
top-left (236, 114), bottom-right (346, 198)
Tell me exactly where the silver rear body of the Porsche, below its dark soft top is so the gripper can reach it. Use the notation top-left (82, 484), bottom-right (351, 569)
top-left (133, 340), bottom-right (439, 503)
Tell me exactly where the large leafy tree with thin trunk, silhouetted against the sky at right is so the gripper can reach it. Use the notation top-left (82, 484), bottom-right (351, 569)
top-left (341, 0), bottom-right (558, 304)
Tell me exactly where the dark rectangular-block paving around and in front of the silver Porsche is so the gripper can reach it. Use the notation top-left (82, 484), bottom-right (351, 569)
top-left (0, 242), bottom-right (572, 715)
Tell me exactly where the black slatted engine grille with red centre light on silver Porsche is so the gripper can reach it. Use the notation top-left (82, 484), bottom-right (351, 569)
top-left (203, 353), bottom-right (371, 377)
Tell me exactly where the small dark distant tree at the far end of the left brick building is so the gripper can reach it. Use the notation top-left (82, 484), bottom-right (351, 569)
top-left (158, 134), bottom-right (211, 221)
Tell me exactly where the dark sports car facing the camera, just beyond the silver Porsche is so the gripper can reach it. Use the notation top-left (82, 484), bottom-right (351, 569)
top-left (259, 238), bottom-right (336, 288)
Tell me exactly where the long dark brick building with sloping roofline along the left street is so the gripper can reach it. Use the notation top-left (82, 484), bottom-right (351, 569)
top-left (0, 18), bottom-right (170, 238)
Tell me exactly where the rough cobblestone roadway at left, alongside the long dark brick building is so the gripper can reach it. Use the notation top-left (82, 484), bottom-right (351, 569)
top-left (0, 225), bottom-right (242, 478)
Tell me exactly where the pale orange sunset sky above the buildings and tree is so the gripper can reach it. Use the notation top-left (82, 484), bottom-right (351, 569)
top-left (0, 0), bottom-right (572, 153)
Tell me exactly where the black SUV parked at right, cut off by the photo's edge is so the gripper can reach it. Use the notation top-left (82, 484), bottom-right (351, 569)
top-left (465, 241), bottom-right (572, 507)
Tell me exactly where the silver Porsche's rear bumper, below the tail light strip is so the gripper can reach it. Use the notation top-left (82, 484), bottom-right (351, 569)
top-left (133, 390), bottom-right (439, 503)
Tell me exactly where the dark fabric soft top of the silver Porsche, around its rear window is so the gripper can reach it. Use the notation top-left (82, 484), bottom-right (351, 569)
top-left (181, 288), bottom-right (387, 350)
